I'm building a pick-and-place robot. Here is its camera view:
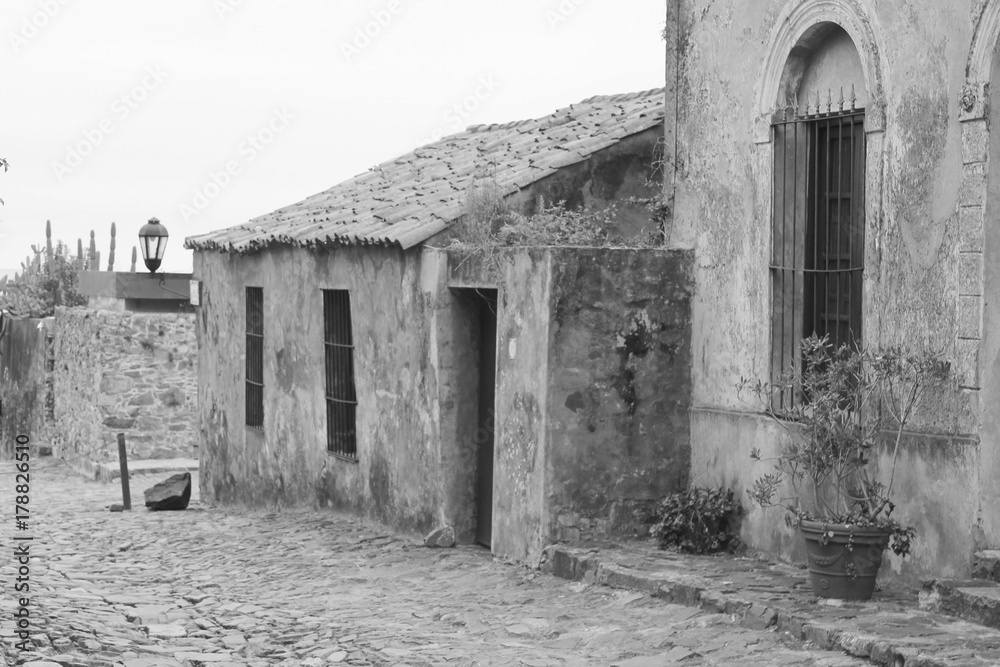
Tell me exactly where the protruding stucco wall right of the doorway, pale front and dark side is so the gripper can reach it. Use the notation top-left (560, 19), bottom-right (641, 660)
top-left (448, 248), bottom-right (693, 562)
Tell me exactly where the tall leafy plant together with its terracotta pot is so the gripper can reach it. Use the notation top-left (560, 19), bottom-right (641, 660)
top-left (739, 336), bottom-right (950, 600)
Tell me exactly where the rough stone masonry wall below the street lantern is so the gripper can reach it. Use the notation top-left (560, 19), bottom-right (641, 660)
top-left (53, 308), bottom-right (198, 468)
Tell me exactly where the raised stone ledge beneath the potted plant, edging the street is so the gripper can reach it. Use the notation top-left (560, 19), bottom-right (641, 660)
top-left (541, 544), bottom-right (1000, 667)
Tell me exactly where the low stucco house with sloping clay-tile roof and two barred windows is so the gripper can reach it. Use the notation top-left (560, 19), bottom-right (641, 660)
top-left (185, 89), bottom-right (691, 561)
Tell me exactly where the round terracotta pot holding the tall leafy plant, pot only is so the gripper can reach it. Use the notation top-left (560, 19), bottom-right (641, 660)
top-left (799, 521), bottom-right (889, 600)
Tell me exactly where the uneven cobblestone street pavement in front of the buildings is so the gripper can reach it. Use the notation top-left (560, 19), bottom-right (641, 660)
top-left (0, 459), bottom-right (867, 667)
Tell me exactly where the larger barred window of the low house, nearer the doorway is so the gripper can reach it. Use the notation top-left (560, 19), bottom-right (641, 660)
top-left (323, 290), bottom-right (358, 460)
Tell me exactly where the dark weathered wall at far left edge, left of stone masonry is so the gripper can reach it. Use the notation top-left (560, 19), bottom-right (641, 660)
top-left (0, 318), bottom-right (52, 459)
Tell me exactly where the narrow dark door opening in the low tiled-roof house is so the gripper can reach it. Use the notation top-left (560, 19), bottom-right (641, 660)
top-left (475, 290), bottom-right (497, 547)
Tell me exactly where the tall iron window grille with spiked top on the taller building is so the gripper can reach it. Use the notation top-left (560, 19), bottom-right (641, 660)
top-left (771, 92), bottom-right (865, 410)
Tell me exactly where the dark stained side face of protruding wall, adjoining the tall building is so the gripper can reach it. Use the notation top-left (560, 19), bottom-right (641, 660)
top-left (546, 249), bottom-right (693, 542)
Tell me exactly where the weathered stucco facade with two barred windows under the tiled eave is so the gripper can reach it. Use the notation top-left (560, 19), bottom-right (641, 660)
top-left (194, 247), bottom-right (442, 531)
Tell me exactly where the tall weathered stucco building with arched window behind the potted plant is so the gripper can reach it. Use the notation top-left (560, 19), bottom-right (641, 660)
top-left (665, 0), bottom-right (1000, 578)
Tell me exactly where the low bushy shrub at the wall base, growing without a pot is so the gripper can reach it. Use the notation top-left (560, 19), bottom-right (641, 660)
top-left (650, 487), bottom-right (743, 554)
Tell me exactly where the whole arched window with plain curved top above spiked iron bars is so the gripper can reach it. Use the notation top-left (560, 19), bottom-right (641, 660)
top-left (771, 23), bottom-right (867, 408)
